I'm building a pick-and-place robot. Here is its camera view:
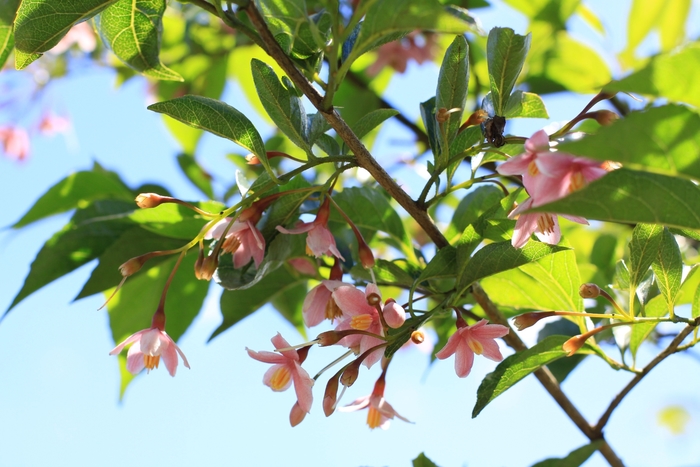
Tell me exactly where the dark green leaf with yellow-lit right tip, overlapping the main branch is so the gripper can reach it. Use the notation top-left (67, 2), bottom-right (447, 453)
top-left (457, 240), bottom-right (568, 295)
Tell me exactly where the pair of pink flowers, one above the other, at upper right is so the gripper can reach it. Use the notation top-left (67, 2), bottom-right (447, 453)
top-left (498, 130), bottom-right (607, 248)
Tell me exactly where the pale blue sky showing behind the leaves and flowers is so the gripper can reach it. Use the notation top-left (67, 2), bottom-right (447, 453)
top-left (0, 1), bottom-right (700, 467)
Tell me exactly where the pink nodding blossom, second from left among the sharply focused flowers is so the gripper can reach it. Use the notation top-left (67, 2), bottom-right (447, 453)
top-left (204, 217), bottom-right (265, 268)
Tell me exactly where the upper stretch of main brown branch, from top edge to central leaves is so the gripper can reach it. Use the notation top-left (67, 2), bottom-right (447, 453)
top-left (245, 2), bottom-right (449, 248)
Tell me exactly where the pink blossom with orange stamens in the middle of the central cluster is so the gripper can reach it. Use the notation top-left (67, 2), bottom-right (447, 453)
top-left (332, 285), bottom-right (384, 368)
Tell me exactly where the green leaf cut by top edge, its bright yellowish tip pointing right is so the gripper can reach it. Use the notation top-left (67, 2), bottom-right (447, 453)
top-left (344, 0), bottom-right (471, 62)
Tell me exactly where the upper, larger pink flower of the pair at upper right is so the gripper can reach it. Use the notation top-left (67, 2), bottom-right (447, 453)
top-left (497, 130), bottom-right (607, 206)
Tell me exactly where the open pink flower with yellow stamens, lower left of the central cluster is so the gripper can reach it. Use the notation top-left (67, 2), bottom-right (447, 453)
top-left (246, 333), bottom-right (314, 414)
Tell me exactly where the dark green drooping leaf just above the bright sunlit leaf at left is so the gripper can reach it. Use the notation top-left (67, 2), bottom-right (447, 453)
top-left (75, 226), bottom-right (183, 300)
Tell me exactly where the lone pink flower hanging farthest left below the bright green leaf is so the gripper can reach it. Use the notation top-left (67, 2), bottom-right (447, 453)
top-left (109, 327), bottom-right (190, 376)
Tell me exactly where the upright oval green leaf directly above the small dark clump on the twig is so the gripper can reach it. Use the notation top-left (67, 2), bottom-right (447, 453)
top-left (486, 28), bottom-right (530, 116)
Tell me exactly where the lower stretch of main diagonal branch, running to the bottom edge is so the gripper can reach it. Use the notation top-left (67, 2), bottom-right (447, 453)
top-left (472, 283), bottom-right (624, 467)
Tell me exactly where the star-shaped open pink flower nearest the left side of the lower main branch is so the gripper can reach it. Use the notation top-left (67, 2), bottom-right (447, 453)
top-left (435, 319), bottom-right (508, 378)
